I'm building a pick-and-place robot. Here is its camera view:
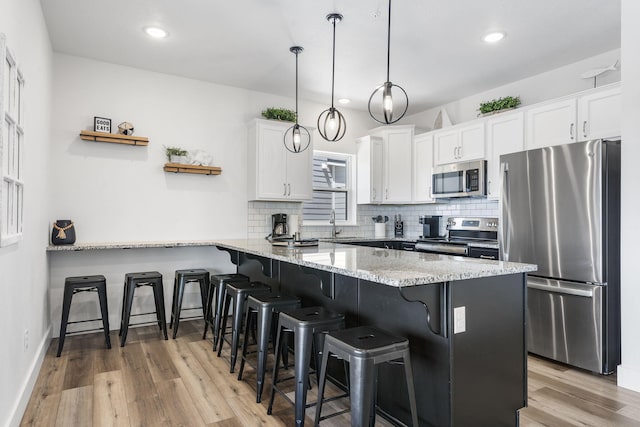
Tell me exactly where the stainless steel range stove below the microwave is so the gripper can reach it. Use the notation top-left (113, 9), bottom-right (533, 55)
top-left (415, 217), bottom-right (498, 259)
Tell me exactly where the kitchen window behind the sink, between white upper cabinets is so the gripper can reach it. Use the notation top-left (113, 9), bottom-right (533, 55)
top-left (302, 151), bottom-right (356, 225)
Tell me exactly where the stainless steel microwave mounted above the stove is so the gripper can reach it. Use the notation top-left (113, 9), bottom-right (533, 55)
top-left (431, 160), bottom-right (487, 198)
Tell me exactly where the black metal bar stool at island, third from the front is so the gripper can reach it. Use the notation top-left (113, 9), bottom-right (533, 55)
top-left (238, 292), bottom-right (300, 403)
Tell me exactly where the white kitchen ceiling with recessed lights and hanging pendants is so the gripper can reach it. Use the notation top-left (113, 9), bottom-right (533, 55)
top-left (41, 0), bottom-right (621, 113)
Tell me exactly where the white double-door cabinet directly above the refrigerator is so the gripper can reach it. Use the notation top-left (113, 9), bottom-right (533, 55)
top-left (526, 85), bottom-right (621, 149)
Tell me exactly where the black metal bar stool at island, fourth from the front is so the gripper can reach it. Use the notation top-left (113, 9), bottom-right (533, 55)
top-left (218, 282), bottom-right (271, 373)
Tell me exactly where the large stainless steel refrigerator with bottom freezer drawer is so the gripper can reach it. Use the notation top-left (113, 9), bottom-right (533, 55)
top-left (499, 140), bottom-right (620, 374)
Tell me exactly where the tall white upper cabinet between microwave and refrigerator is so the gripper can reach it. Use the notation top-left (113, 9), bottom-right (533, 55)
top-left (486, 112), bottom-right (524, 199)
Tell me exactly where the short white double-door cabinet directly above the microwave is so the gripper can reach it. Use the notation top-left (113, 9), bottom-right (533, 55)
top-left (433, 122), bottom-right (485, 165)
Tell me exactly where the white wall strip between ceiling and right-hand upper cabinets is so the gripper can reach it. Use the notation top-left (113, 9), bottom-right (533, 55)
top-left (403, 49), bottom-right (624, 129)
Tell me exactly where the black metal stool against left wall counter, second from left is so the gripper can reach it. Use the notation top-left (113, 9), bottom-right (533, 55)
top-left (119, 271), bottom-right (167, 347)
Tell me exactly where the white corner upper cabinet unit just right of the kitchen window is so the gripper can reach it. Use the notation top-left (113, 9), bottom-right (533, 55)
top-left (356, 126), bottom-right (414, 204)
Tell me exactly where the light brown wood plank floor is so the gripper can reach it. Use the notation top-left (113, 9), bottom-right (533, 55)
top-left (21, 321), bottom-right (640, 427)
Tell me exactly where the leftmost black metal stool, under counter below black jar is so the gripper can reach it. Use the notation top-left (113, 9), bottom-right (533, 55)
top-left (56, 275), bottom-right (111, 357)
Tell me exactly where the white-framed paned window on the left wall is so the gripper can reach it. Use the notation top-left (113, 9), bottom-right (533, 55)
top-left (0, 34), bottom-right (24, 246)
